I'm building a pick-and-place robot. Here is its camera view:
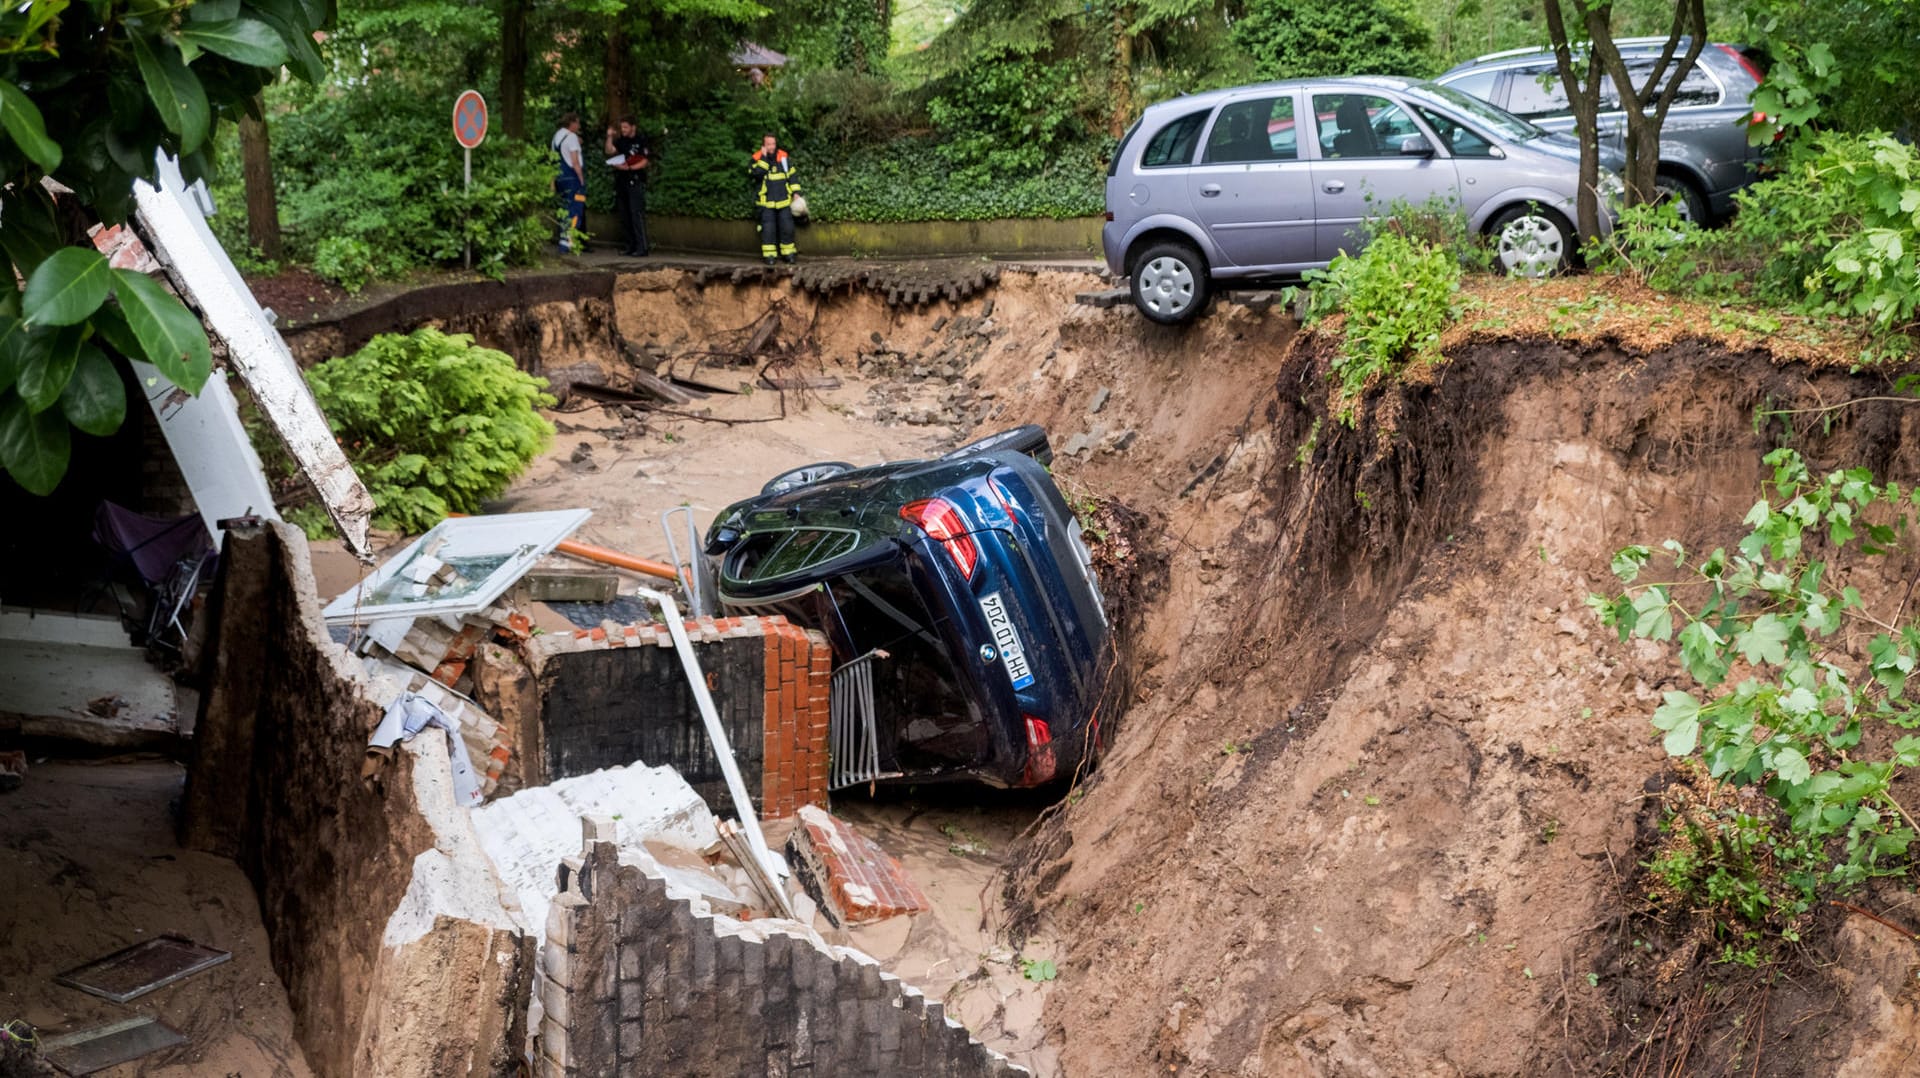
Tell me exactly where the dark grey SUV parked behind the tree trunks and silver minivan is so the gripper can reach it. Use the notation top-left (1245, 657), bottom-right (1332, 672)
top-left (1434, 37), bottom-right (1761, 225)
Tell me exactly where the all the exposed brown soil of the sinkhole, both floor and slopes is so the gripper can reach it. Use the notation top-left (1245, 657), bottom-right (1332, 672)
top-left (284, 269), bottom-right (1920, 1076)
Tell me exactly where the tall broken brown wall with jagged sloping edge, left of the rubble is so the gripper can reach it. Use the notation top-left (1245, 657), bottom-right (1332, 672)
top-left (182, 525), bottom-right (532, 1076)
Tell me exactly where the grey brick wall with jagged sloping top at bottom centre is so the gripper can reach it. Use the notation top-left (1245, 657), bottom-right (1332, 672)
top-left (534, 819), bottom-right (1027, 1078)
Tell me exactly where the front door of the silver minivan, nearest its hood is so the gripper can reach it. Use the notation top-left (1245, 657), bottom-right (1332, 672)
top-left (1313, 90), bottom-right (1459, 261)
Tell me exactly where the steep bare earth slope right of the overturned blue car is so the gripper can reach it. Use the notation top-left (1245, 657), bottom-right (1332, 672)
top-left (967, 307), bottom-right (1920, 1074)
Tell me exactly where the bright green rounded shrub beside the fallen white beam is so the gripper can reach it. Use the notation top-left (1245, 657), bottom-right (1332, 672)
top-left (307, 327), bottom-right (553, 532)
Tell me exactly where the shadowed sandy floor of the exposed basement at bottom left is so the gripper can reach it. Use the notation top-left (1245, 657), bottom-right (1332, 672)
top-left (0, 759), bottom-right (309, 1078)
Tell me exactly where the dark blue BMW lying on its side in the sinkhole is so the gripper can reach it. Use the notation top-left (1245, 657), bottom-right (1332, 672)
top-left (707, 427), bottom-right (1112, 788)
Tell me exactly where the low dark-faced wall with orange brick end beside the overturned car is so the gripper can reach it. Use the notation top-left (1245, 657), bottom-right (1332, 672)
top-left (528, 617), bottom-right (831, 819)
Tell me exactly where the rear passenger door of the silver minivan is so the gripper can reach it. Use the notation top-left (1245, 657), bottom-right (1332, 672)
top-left (1187, 90), bottom-right (1313, 269)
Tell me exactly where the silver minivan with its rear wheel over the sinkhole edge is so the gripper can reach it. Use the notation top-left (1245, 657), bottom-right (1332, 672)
top-left (1100, 77), bottom-right (1626, 323)
